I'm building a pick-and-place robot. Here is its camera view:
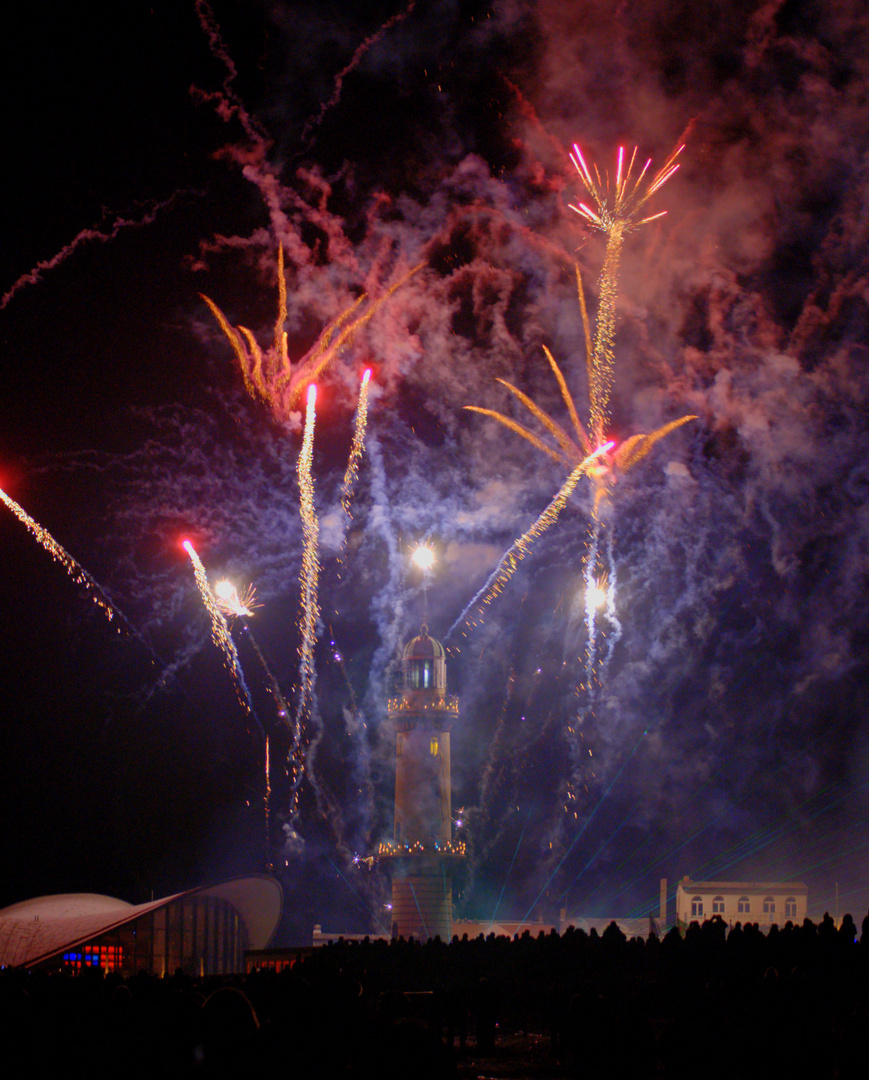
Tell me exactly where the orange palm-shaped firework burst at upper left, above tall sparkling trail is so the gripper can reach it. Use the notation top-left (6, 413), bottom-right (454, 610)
top-left (200, 245), bottom-right (423, 419)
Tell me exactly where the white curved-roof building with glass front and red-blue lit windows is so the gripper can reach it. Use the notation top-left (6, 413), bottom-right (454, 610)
top-left (0, 876), bottom-right (283, 975)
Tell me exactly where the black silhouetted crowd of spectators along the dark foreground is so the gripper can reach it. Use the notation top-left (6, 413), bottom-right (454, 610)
top-left (0, 915), bottom-right (869, 1080)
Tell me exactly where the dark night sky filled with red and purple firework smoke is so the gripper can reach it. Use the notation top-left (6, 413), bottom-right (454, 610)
top-left (0, 0), bottom-right (869, 935)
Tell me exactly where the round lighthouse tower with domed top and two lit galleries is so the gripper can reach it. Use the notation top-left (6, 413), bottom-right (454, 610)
top-left (379, 625), bottom-right (465, 941)
